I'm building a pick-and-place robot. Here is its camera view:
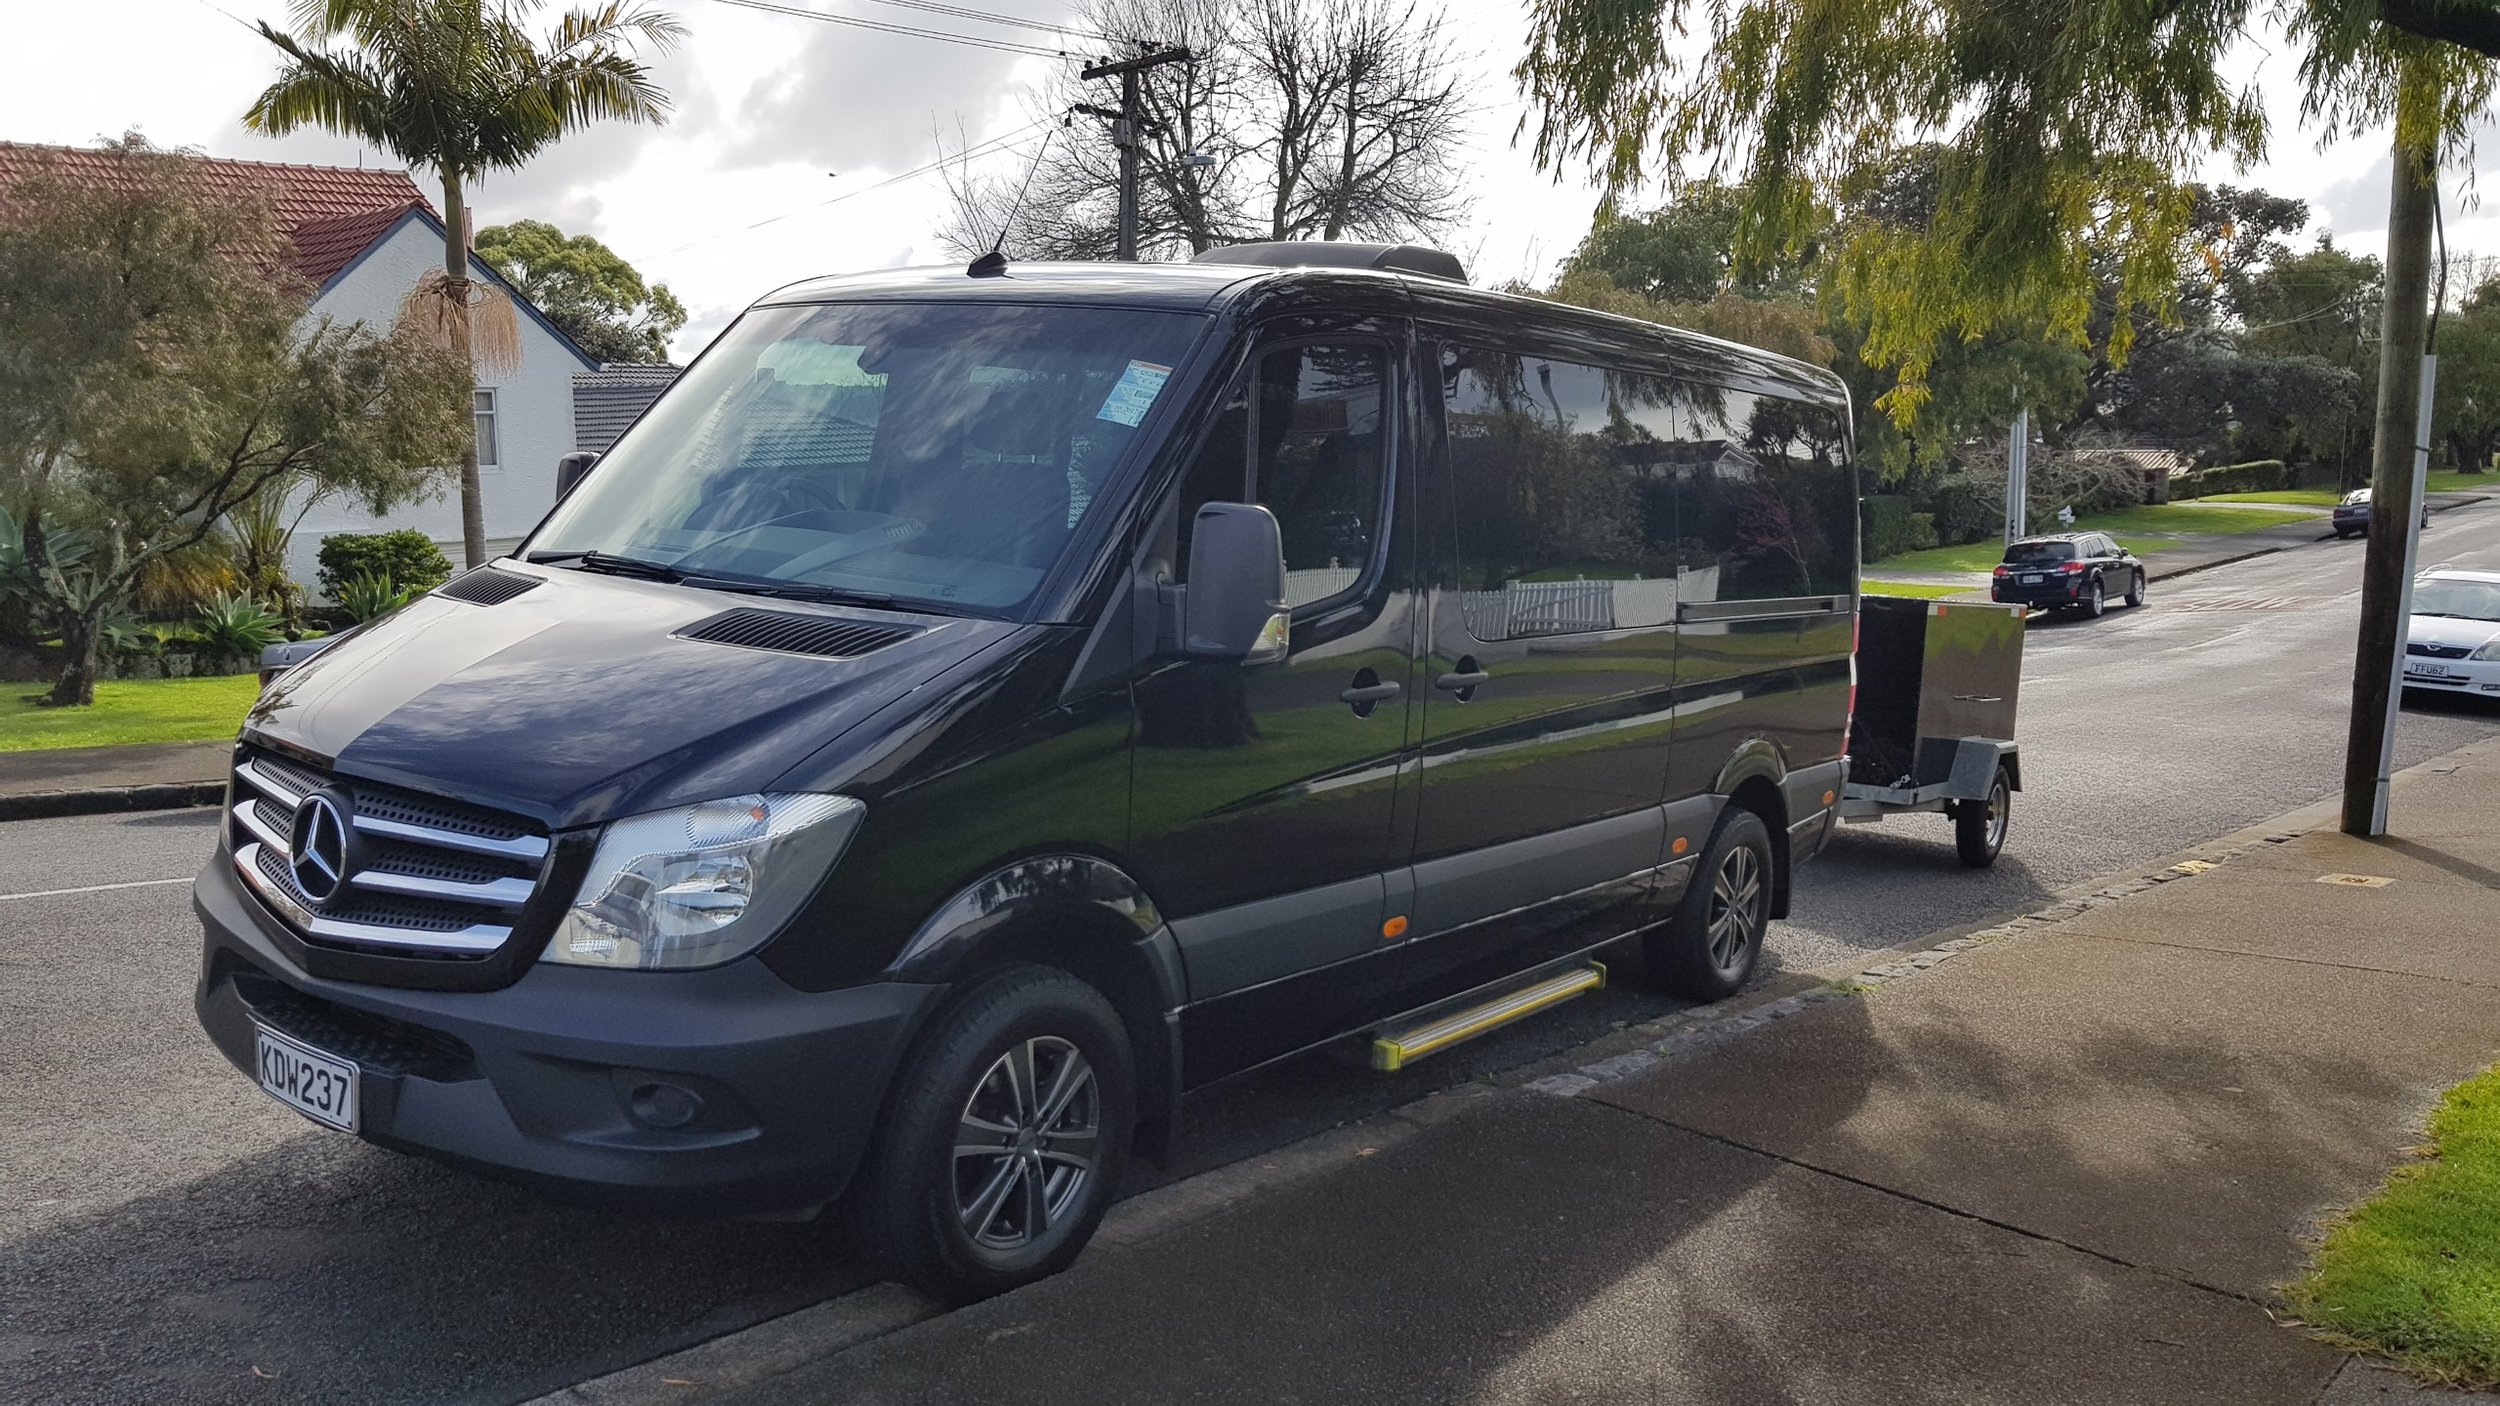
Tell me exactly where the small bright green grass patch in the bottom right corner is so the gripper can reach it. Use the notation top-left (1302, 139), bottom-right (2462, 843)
top-left (2288, 1066), bottom-right (2500, 1386)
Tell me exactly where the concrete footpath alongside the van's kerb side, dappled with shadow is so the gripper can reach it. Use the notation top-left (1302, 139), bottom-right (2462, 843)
top-left (550, 746), bottom-right (2500, 1403)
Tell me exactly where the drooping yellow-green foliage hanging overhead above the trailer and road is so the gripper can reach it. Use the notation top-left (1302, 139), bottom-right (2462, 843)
top-left (1518, 0), bottom-right (2495, 428)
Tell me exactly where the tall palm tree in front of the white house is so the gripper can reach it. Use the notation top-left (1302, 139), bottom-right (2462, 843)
top-left (243, 0), bottom-right (685, 565)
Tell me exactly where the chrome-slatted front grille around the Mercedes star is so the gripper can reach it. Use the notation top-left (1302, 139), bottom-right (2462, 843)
top-left (228, 748), bottom-right (548, 961)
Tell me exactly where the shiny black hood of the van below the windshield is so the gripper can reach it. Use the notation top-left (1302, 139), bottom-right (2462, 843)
top-left (243, 563), bottom-right (1025, 828)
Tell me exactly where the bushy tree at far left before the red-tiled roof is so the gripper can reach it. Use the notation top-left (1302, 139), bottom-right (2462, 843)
top-left (0, 138), bottom-right (470, 706)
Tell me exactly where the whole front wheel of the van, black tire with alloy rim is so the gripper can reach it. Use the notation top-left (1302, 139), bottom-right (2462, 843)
top-left (850, 963), bottom-right (1138, 1303)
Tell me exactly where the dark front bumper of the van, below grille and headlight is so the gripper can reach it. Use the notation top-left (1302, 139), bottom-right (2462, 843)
top-left (193, 851), bottom-right (943, 1216)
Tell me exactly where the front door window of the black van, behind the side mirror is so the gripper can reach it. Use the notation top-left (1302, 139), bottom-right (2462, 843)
top-left (1180, 343), bottom-right (1390, 605)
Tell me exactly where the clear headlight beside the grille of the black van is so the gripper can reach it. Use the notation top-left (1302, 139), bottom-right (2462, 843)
top-left (543, 796), bottom-right (868, 971)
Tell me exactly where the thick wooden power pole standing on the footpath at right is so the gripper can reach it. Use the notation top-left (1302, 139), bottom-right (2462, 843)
top-left (2343, 118), bottom-right (2440, 836)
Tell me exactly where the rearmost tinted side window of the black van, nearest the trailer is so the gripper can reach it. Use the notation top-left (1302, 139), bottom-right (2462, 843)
top-left (1675, 385), bottom-right (1858, 603)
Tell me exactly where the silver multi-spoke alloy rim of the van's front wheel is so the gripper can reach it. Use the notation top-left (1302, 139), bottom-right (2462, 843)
top-left (953, 1036), bottom-right (1103, 1253)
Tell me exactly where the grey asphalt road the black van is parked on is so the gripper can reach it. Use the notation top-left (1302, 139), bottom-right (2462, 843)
top-left (0, 503), bottom-right (2500, 1403)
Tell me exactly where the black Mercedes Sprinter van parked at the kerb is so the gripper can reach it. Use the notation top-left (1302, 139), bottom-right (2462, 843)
top-left (195, 245), bottom-right (1858, 1298)
